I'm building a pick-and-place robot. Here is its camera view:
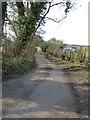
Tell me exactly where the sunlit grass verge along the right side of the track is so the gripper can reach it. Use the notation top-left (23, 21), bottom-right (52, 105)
top-left (46, 54), bottom-right (90, 83)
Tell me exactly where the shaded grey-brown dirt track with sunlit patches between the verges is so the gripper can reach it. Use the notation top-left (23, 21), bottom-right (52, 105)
top-left (2, 53), bottom-right (87, 118)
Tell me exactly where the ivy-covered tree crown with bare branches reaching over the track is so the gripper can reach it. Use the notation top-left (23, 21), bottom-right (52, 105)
top-left (2, 0), bottom-right (75, 54)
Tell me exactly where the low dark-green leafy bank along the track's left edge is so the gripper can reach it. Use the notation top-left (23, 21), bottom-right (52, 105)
top-left (2, 58), bottom-right (34, 80)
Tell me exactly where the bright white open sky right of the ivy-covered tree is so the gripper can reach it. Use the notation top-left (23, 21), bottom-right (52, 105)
top-left (43, 0), bottom-right (89, 45)
